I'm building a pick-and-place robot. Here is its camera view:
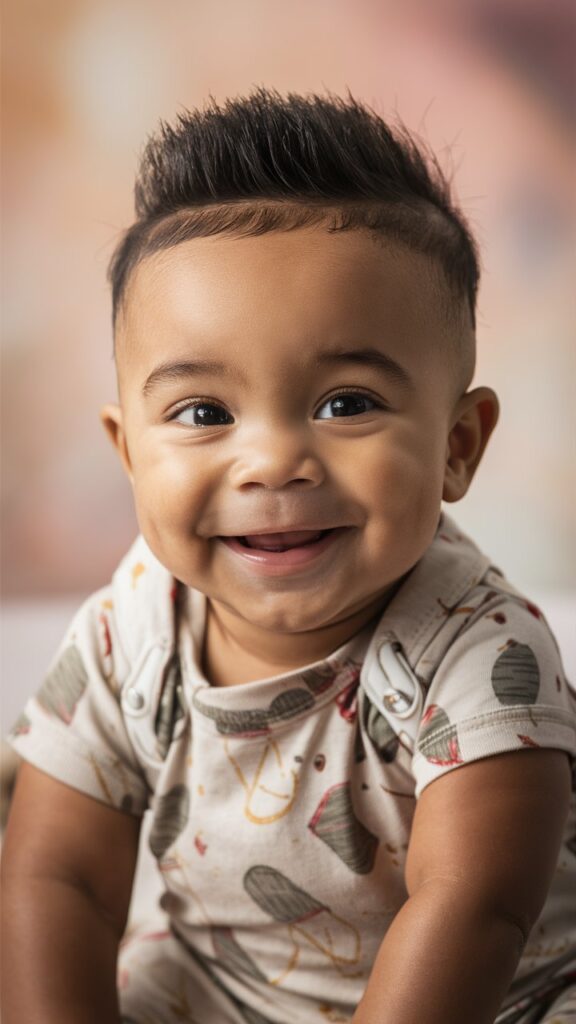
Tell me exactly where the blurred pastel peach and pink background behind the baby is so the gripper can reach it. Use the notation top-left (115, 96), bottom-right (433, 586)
top-left (2, 0), bottom-right (576, 731)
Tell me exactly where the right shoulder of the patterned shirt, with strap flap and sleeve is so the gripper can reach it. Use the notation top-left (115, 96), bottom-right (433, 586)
top-left (356, 516), bottom-right (576, 796)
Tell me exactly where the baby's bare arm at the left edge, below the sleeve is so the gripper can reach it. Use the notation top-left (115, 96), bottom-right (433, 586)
top-left (2, 763), bottom-right (140, 1024)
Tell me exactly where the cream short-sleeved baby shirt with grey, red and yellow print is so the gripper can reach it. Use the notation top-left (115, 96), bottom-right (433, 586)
top-left (10, 515), bottom-right (576, 1024)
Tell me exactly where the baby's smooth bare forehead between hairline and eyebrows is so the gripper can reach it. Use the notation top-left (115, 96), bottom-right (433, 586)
top-left (117, 227), bottom-right (450, 373)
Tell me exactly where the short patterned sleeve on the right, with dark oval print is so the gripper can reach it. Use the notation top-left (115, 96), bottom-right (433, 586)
top-left (412, 599), bottom-right (576, 797)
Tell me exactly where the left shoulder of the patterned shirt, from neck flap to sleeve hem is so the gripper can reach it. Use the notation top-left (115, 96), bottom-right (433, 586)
top-left (4, 538), bottom-right (174, 814)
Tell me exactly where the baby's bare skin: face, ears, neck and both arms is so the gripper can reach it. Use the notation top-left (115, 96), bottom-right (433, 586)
top-left (2, 228), bottom-right (570, 1024)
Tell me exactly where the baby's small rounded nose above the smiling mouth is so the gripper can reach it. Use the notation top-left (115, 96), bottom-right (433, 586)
top-left (231, 426), bottom-right (325, 490)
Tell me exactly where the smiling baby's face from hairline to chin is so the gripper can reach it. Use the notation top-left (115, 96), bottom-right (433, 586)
top-left (104, 227), bottom-right (475, 633)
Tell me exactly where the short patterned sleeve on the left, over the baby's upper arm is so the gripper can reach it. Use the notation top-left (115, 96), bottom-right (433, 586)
top-left (7, 587), bottom-right (149, 816)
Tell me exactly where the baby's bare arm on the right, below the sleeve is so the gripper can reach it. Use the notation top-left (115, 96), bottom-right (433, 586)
top-left (354, 750), bottom-right (570, 1024)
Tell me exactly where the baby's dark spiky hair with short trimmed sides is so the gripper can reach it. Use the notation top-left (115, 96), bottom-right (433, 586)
top-left (109, 87), bottom-right (480, 324)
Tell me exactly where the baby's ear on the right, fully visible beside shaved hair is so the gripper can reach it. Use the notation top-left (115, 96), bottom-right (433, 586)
top-left (442, 387), bottom-right (500, 502)
